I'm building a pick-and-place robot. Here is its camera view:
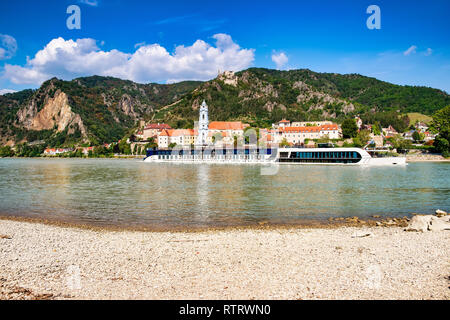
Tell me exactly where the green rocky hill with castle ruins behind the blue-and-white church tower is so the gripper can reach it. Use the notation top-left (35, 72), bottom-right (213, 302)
top-left (160, 68), bottom-right (450, 125)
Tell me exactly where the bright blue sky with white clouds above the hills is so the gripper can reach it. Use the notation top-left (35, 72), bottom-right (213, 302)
top-left (0, 0), bottom-right (450, 94)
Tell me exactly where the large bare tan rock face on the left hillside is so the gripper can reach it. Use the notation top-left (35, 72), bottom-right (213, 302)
top-left (17, 90), bottom-right (86, 136)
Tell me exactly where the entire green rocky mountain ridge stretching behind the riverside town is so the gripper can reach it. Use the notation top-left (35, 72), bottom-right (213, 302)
top-left (0, 68), bottom-right (450, 145)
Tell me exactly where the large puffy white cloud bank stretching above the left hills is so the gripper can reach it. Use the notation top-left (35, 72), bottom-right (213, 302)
top-left (3, 34), bottom-right (254, 85)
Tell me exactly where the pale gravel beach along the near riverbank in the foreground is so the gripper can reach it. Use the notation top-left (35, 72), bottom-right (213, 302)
top-left (0, 220), bottom-right (450, 300)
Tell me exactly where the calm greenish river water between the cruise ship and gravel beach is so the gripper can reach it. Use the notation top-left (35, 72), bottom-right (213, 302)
top-left (0, 159), bottom-right (450, 228)
